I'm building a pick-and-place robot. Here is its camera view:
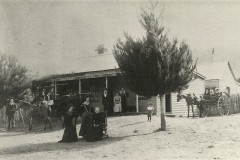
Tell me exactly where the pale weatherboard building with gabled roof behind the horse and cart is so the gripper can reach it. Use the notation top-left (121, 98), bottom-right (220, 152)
top-left (165, 61), bottom-right (240, 116)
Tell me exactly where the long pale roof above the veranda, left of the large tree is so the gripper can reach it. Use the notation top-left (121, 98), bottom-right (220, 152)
top-left (36, 53), bottom-right (118, 81)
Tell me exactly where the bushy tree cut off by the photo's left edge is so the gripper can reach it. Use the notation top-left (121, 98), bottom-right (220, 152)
top-left (0, 55), bottom-right (31, 107)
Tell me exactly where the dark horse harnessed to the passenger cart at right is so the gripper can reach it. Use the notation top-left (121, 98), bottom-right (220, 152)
top-left (177, 92), bottom-right (200, 118)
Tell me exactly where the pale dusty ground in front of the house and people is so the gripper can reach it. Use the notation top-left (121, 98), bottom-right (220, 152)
top-left (0, 114), bottom-right (240, 160)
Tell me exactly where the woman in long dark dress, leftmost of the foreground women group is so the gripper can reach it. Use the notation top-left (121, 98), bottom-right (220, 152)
top-left (58, 105), bottom-right (78, 143)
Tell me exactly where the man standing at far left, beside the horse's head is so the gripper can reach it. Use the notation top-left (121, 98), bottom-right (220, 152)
top-left (6, 98), bottom-right (17, 130)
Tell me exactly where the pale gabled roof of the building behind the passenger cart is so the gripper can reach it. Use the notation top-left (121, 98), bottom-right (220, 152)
top-left (196, 61), bottom-right (236, 80)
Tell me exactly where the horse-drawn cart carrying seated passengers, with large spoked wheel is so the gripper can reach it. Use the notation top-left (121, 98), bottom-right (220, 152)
top-left (203, 80), bottom-right (230, 116)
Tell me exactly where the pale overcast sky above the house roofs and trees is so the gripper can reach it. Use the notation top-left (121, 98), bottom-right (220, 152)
top-left (0, 0), bottom-right (240, 77)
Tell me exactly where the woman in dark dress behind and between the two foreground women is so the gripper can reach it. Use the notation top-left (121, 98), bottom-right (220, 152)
top-left (79, 96), bottom-right (94, 138)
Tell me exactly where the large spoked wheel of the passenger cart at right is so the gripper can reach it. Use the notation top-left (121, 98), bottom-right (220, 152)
top-left (218, 94), bottom-right (230, 116)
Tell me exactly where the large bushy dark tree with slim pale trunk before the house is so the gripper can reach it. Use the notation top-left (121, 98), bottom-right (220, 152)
top-left (113, 6), bottom-right (196, 130)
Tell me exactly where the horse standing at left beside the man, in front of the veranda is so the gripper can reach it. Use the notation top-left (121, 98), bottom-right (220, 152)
top-left (18, 100), bottom-right (52, 131)
